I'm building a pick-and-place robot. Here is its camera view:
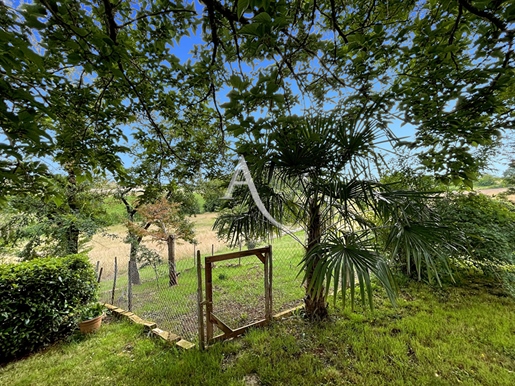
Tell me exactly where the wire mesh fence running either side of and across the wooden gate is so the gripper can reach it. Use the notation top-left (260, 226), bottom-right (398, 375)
top-left (100, 232), bottom-right (304, 341)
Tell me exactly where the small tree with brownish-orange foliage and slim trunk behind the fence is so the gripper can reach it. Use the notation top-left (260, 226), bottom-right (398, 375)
top-left (128, 197), bottom-right (194, 286)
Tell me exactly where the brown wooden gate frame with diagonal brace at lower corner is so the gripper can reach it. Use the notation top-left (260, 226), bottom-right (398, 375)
top-left (197, 246), bottom-right (272, 348)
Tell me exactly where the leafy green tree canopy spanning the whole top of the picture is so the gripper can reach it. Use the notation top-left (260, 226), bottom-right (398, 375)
top-left (0, 0), bottom-right (515, 190)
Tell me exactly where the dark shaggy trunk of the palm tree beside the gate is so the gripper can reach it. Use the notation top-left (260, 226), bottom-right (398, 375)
top-left (304, 198), bottom-right (328, 320)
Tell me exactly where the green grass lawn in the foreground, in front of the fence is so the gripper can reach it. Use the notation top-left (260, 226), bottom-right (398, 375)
top-left (0, 272), bottom-right (515, 386)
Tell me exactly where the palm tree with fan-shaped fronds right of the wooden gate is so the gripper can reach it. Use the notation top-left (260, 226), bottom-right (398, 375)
top-left (215, 109), bottom-right (454, 319)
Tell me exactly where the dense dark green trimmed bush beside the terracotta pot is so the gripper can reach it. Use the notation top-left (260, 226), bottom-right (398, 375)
top-left (0, 255), bottom-right (97, 362)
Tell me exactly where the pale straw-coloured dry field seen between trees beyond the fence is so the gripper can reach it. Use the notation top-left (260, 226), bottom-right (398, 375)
top-left (88, 213), bottom-right (225, 279)
